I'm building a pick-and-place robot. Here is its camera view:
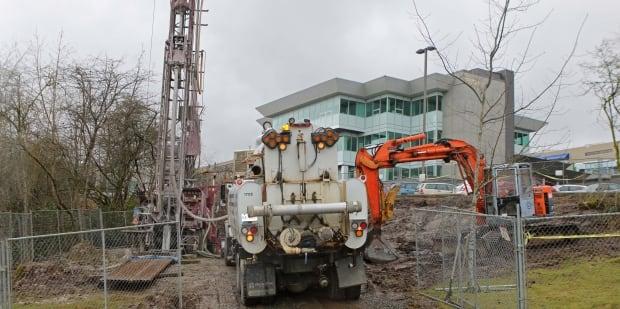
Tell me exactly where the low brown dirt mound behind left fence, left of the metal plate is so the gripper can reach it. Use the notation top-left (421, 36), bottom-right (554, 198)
top-left (13, 262), bottom-right (98, 298)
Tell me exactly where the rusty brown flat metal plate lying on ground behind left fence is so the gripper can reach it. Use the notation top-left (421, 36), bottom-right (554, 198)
top-left (107, 258), bottom-right (172, 282)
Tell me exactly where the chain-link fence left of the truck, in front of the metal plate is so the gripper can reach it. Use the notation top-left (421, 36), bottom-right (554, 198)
top-left (0, 222), bottom-right (182, 308)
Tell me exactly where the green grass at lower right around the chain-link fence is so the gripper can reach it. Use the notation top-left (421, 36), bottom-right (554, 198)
top-left (424, 258), bottom-right (620, 308)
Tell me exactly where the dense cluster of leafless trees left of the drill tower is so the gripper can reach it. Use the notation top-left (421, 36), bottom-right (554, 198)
top-left (0, 36), bottom-right (157, 211)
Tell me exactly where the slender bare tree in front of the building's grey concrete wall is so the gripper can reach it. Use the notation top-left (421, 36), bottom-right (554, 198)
top-left (413, 0), bottom-right (585, 205)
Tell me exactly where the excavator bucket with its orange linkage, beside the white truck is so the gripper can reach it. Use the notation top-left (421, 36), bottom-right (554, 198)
top-left (364, 186), bottom-right (400, 264)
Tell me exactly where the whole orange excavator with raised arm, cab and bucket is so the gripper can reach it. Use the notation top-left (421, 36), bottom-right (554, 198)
top-left (355, 133), bottom-right (553, 263)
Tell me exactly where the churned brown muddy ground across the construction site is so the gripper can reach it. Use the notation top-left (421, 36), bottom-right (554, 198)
top-left (15, 191), bottom-right (620, 309)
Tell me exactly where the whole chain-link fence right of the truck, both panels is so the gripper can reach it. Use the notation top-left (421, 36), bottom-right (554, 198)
top-left (413, 208), bottom-right (620, 308)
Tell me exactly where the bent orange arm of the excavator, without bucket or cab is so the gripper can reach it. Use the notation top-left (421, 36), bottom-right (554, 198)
top-left (355, 133), bottom-right (486, 225)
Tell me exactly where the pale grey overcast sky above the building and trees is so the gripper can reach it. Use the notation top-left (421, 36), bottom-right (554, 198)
top-left (0, 0), bottom-right (620, 162)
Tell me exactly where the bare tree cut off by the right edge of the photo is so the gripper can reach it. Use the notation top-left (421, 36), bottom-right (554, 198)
top-left (581, 37), bottom-right (620, 170)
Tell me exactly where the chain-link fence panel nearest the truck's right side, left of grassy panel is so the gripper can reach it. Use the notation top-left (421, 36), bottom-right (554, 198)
top-left (413, 208), bottom-right (518, 308)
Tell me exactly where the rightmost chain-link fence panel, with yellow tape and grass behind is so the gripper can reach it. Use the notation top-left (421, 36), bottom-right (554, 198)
top-left (523, 213), bottom-right (620, 308)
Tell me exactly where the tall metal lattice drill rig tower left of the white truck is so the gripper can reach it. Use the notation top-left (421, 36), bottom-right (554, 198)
top-left (154, 0), bottom-right (204, 251)
